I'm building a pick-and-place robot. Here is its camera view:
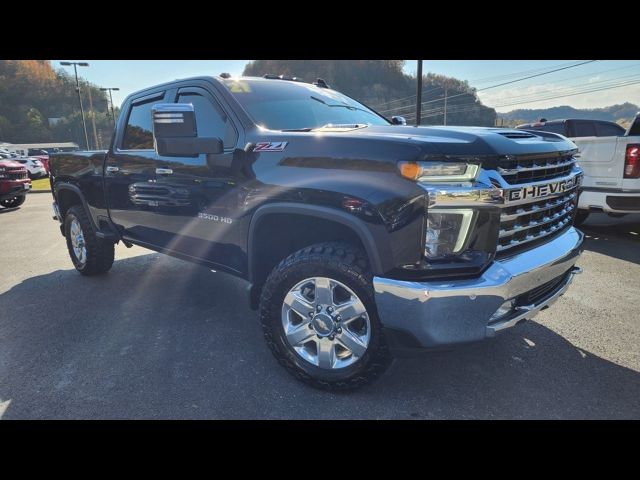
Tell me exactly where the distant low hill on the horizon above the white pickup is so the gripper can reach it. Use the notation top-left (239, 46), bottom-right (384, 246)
top-left (498, 102), bottom-right (640, 124)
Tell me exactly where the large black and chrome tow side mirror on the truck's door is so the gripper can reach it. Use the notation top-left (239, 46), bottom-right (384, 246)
top-left (151, 103), bottom-right (224, 157)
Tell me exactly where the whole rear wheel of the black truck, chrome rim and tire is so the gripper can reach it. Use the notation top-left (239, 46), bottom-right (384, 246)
top-left (64, 205), bottom-right (115, 275)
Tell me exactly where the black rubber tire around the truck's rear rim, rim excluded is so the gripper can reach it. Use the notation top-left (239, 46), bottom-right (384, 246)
top-left (64, 205), bottom-right (115, 275)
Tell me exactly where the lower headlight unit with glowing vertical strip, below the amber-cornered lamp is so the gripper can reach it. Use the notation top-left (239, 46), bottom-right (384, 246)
top-left (424, 208), bottom-right (474, 260)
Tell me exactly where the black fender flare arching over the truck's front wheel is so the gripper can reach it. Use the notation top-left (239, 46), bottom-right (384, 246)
top-left (247, 202), bottom-right (383, 282)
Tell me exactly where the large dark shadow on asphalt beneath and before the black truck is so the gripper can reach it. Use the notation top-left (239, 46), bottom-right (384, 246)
top-left (0, 254), bottom-right (640, 418)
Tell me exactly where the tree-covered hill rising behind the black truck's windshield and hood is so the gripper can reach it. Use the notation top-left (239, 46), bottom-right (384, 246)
top-left (244, 60), bottom-right (496, 126)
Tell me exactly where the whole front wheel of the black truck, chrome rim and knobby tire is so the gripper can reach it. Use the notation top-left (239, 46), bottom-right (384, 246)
top-left (260, 243), bottom-right (391, 390)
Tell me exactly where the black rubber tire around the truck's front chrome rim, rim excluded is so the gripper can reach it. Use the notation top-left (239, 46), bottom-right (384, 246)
top-left (260, 242), bottom-right (392, 391)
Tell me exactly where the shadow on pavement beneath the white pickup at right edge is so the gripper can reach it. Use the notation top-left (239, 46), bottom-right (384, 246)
top-left (579, 213), bottom-right (640, 264)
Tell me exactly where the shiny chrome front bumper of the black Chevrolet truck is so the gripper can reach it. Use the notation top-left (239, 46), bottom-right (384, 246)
top-left (373, 227), bottom-right (584, 348)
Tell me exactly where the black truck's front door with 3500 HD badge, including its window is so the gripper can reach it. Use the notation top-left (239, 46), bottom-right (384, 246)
top-left (151, 85), bottom-right (248, 272)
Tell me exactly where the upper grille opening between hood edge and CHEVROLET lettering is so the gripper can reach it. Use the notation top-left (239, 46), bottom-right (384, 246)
top-left (497, 153), bottom-right (576, 185)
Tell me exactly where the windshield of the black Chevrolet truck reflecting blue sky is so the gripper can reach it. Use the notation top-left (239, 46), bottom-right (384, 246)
top-left (223, 79), bottom-right (389, 130)
